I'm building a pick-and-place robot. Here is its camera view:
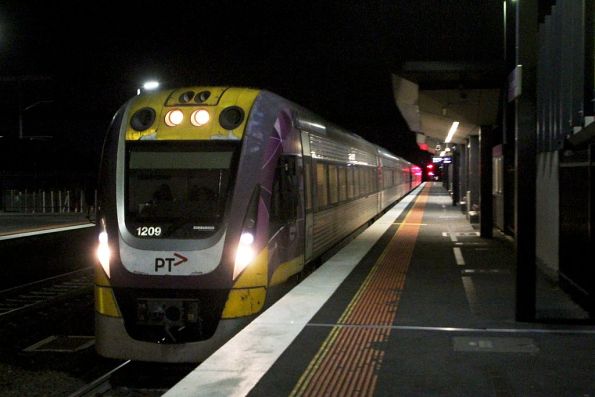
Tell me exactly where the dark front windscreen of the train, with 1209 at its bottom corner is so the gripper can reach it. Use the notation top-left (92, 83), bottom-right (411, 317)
top-left (125, 141), bottom-right (239, 239)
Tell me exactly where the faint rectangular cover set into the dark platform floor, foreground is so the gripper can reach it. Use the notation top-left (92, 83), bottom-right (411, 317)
top-left (452, 336), bottom-right (539, 353)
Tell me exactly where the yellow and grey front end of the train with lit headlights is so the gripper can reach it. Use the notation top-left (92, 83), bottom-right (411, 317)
top-left (95, 87), bottom-right (267, 362)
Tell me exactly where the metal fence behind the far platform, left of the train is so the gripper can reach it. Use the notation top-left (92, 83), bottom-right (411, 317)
top-left (0, 189), bottom-right (97, 214)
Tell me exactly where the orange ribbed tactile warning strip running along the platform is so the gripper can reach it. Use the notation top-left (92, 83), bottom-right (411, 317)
top-left (290, 185), bottom-right (430, 396)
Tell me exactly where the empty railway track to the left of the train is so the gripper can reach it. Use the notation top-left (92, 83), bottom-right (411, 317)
top-left (0, 267), bottom-right (93, 321)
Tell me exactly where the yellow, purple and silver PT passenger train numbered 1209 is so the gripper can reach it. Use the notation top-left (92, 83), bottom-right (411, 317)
top-left (95, 86), bottom-right (422, 362)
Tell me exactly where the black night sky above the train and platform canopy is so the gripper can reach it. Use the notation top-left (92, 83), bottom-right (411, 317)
top-left (0, 0), bottom-right (502, 179)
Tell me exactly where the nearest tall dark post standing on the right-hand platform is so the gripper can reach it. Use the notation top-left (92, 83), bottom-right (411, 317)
top-left (512, 0), bottom-right (538, 321)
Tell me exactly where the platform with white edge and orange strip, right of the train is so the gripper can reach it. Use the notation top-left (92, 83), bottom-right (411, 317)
top-left (165, 183), bottom-right (595, 397)
